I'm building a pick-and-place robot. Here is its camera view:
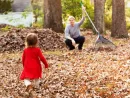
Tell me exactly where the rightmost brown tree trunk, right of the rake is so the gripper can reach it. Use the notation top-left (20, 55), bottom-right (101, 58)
top-left (111, 0), bottom-right (128, 38)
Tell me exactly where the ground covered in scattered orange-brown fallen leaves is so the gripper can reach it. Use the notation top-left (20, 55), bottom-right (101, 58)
top-left (0, 31), bottom-right (130, 98)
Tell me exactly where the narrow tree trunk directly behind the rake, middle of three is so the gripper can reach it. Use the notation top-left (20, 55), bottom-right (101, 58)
top-left (94, 0), bottom-right (105, 33)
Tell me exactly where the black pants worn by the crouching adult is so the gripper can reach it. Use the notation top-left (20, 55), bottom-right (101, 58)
top-left (65, 36), bottom-right (85, 50)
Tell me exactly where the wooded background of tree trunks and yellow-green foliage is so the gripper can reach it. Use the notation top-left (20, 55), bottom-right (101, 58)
top-left (0, 0), bottom-right (130, 37)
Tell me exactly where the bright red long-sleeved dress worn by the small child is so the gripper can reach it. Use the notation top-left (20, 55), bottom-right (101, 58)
top-left (20, 47), bottom-right (48, 80)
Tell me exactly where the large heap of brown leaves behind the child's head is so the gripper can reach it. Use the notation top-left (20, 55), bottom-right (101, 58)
top-left (0, 28), bottom-right (64, 52)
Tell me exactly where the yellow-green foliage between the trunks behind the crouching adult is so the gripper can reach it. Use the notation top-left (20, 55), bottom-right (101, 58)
top-left (62, 0), bottom-right (94, 28)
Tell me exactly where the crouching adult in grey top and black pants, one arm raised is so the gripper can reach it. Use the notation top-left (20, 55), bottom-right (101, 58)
top-left (65, 6), bottom-right (85, 51)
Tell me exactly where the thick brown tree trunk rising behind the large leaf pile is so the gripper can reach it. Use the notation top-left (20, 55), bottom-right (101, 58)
top-left (44, 0), bottom-right (63, 32)
